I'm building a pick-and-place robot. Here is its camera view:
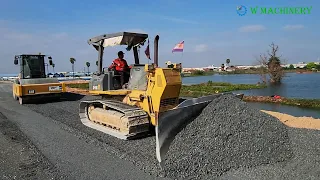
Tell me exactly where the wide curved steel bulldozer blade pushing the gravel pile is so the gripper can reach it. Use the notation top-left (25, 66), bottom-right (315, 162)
top-left (156, 93), bottom-right (243, 165)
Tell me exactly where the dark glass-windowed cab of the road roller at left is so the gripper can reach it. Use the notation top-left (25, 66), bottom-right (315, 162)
top-left (14, 54), bottom-right (52, 79)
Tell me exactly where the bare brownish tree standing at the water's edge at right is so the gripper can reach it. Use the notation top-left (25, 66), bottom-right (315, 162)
top-left (258, 43), bottom-right (284, 84)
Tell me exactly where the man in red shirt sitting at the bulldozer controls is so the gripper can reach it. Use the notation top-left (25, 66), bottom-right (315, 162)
top-left (109, 51), bottom-right (130, 86)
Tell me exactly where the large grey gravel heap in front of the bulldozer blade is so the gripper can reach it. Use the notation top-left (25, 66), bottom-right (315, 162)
top-left (164, 95), bottom-right (293, 179)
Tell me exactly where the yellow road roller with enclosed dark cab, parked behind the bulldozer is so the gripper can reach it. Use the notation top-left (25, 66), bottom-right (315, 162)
top-left (12, 54), bottom-right (66, 104)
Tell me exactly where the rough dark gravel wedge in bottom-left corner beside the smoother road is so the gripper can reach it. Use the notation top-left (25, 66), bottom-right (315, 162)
top-left (0, 108), bottom-right (64, 180)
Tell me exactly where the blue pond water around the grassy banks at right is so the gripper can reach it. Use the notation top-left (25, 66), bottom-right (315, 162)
top-left (182, 73), bottom-right (320, 118)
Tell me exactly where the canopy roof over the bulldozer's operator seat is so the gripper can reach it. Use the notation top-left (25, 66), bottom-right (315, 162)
top-left (88, 32), bottom-right (148, 51)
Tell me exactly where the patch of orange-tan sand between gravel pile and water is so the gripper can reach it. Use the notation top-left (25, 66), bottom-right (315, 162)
top-left (261, 110), bottom-right (320, 130)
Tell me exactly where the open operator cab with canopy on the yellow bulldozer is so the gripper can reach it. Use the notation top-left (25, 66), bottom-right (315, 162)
top-left (88, 32), bottom-right (148, 91)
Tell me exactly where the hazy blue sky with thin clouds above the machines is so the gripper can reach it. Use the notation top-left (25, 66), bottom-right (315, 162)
top-left (0, 0), bottom-right (320, 74)
